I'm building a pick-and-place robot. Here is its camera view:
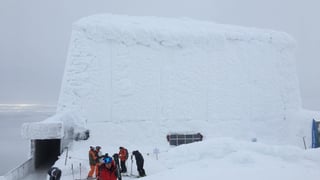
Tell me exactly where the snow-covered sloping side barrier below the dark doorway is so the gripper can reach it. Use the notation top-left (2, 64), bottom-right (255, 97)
top-left (4, 158), bottom-right (34, 180)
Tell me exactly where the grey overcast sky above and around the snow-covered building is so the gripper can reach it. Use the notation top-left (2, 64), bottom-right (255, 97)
top-left (0, 0), bottom-right (320, 110)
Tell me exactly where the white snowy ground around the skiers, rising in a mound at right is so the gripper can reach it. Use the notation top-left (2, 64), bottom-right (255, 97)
top-left (50, 122), bottom-right (320, 180)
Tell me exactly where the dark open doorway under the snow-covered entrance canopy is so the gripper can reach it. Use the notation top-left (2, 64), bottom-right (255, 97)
top-left (34, 139), bottom-right (61, 169)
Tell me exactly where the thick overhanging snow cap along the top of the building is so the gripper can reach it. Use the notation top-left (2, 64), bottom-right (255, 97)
top-left (73, 14), bottom-right (294, 49)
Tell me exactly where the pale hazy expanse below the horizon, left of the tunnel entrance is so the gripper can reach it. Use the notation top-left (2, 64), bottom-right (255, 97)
top-left (0, 109), bottom-right (54, 176)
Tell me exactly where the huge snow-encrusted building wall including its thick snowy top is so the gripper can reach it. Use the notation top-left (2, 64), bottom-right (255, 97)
top-left (58, 15), bottom-right (301, 128)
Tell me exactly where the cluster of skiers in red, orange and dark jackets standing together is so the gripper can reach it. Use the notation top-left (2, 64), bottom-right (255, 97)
top-left (87, 146), bottom-right (146, 180)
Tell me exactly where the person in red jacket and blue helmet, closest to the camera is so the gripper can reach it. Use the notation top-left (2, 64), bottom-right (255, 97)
top-left (98, 157), bottom-right (118, 180)
